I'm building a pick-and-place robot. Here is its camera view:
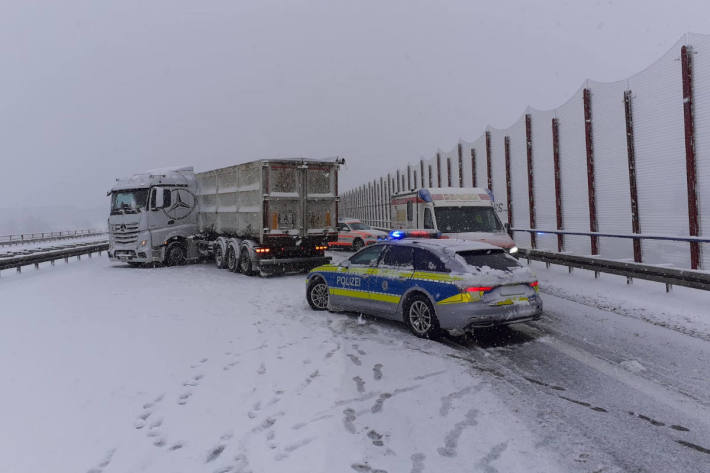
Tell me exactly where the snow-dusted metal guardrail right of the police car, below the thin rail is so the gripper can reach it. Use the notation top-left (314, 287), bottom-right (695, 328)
top-left (519, 248), bottom-right (710, 292)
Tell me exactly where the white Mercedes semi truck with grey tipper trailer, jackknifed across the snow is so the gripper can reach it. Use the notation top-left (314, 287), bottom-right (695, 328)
top-left (108, 158), bottom-right (344, 275)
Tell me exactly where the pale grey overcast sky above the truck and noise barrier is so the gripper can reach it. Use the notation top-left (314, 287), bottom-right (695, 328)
top-left (0, 0), bottom-right (710, 207)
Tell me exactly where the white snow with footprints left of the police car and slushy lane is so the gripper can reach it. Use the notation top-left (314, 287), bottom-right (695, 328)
top-left (0, 255), bottom-right (561, 473)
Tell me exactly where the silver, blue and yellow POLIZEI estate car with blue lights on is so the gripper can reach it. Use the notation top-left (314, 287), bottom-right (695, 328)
top-left (306, 231), bottom-right (542, 338)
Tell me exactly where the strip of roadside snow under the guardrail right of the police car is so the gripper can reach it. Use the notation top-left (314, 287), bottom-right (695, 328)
top-left (521, 259), bottom-right (710, 341)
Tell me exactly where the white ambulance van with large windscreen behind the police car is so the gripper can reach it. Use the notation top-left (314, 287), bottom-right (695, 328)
top-left (390, 187), bottom-right (518, 253)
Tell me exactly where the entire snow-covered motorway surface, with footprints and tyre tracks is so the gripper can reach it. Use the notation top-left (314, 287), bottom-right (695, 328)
top-left (0, 253), bottom-right (710, 473)
